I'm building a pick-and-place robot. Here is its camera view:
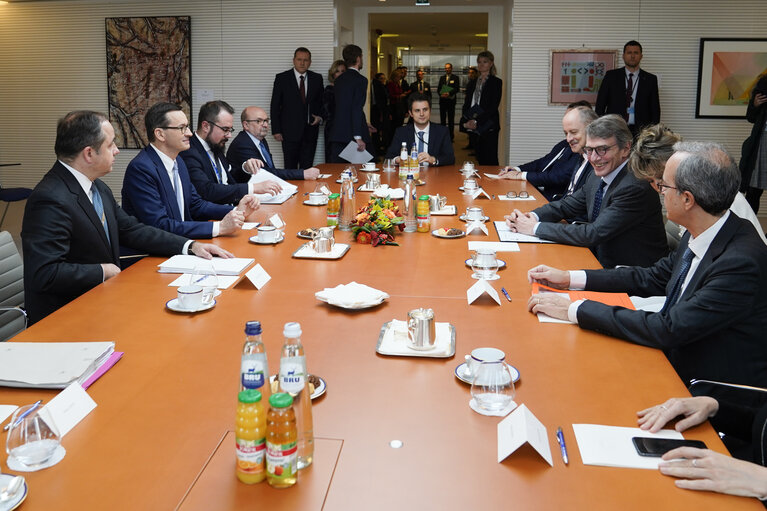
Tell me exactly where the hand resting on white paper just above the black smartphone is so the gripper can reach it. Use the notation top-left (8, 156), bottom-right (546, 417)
top-left (637, 396), bottom-right (719, 433)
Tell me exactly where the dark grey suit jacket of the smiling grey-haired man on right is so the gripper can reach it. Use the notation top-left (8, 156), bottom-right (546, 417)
top-left (533, 165), bottom-right (668, 268)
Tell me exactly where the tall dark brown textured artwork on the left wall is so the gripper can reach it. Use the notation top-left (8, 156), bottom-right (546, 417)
top-left (105, 16), bottom-right (192, 149)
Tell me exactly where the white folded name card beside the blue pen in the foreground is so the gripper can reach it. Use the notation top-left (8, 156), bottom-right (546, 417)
top-left (498, 405), bottom-right (554, 467)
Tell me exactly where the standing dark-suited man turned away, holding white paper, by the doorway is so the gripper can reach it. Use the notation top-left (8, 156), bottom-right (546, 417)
top-left (330, 44), bottom-right (370, 163)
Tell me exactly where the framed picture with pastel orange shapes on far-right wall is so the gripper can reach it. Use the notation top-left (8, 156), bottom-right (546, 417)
top-left (695, 38), bottom-right (767, 119)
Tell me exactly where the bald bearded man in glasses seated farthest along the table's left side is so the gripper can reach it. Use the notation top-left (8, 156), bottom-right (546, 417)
top-left (226, 106), bottom-right (320, 183)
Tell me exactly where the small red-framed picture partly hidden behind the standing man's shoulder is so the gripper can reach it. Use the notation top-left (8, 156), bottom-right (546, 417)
top-left (549, 48), bottom-right (618, 105)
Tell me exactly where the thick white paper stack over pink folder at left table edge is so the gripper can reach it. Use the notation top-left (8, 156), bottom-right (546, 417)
top-left (0, 342), bottom-right (115, 389)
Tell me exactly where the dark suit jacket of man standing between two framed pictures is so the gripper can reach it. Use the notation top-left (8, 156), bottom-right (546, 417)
top-left (594, 67), bottom-right (660, 128)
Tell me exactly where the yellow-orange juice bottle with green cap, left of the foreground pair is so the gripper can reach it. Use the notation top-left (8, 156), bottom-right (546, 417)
top-left (234, 389), bottom-right (266, 484)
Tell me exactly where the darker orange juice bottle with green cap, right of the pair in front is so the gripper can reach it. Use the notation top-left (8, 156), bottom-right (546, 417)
top-left (266, 392), bottom-right (298, 488)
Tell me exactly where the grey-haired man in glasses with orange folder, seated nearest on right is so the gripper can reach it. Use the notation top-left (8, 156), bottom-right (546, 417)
top-left (528, 142), bottom-right (767, 387)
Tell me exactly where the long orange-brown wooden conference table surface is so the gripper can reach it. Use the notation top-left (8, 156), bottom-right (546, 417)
top-left (0, 165), bottom-right (761, 511)
